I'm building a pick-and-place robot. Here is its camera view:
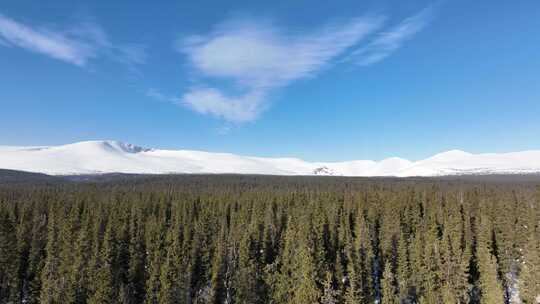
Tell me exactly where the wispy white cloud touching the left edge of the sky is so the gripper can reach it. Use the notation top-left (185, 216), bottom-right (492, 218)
top-left (0, 14), bottom-right (145, 66)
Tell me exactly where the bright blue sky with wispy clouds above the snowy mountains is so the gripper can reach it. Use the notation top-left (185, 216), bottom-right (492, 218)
top-left (0, 0), bottom-right (540, 161)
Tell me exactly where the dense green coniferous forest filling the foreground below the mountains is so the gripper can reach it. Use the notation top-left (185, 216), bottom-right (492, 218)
top-left (0, 175), bottom-right (540, 304)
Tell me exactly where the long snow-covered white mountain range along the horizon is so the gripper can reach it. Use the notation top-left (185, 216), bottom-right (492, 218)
top-left (0, 141), bottom-right (540, 177)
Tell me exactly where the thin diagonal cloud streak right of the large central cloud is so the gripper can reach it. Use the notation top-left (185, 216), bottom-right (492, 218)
top-left (347, 6), bottom-right (434, 66)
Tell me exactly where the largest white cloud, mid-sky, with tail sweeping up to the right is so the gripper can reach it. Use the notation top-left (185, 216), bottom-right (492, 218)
top-left (179, 17), bottom-right (383, 123)
